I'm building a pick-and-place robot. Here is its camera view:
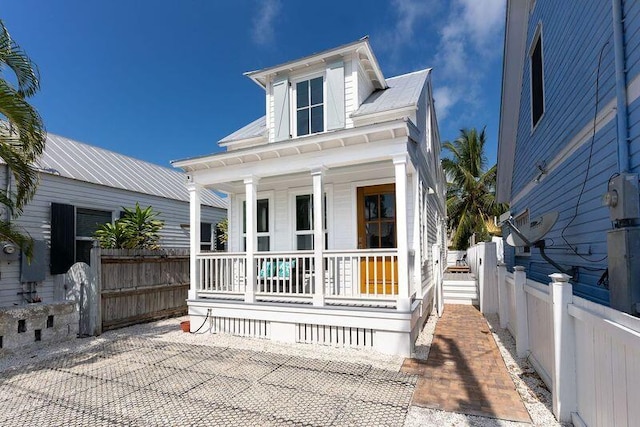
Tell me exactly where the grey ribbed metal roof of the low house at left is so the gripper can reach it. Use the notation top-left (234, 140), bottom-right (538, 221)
top-left (36, 133), bottom-right (227, 209)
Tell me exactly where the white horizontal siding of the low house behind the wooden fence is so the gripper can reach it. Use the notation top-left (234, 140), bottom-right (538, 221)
top-left (0, 168), bottom-right (226, 306)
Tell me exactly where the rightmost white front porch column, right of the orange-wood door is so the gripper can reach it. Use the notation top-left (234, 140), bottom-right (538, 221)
top-left (393, 154), bottom-right (411, 311)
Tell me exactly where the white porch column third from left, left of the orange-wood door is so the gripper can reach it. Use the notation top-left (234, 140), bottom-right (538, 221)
top-left (311, 167), bottom-right (325, 307)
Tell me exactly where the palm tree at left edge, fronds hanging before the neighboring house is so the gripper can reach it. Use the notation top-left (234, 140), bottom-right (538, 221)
top-left (0, 20), bottom-right (46, 257)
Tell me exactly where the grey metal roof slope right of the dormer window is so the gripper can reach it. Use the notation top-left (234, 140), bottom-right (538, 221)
top-left (351, 68), bottom-right (431, 117)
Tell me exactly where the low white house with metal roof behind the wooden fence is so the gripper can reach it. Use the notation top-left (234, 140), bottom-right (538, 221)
top-left (0, 134), bottom-right (226, 307)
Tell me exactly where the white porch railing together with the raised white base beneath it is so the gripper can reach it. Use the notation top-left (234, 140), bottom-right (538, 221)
top-left (188, 249), bottom-right (434, 356)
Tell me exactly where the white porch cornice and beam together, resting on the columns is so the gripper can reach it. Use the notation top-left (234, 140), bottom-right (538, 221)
top-left (174, 119), bottom-right (419, 191)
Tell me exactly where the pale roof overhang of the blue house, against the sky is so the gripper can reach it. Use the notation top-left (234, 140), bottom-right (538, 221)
top-left (496, 0), bottom-right (530, 203)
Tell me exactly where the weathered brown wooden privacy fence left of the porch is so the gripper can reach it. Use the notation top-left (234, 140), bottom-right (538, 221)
top-left (91, 248), bottom-right (189, 334)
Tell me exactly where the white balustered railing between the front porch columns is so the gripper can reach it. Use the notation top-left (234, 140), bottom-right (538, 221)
top-left (196, 249), bottom-right (400, 305)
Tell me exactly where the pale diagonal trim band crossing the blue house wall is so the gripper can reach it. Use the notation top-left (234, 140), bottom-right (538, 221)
top-left (510, 75), bottom-right (640, 206)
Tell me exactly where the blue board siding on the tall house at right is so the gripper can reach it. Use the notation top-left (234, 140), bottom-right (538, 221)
top-left (505, 0), bottom-right (640, 304)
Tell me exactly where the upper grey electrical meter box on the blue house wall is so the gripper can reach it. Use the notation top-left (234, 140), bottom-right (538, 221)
top-left (607, 173), bottom-right (640, 221)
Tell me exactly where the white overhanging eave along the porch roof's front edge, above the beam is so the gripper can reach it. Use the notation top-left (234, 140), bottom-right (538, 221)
top-left (171, 118), bottom-right (410, 172)
